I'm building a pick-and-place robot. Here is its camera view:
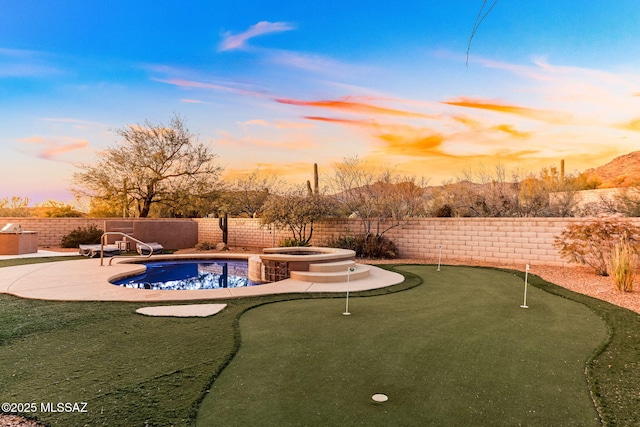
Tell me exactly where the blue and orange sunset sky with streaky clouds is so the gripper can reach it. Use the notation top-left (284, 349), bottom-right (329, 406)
top-left (0, 0), bottom-right (640, 202)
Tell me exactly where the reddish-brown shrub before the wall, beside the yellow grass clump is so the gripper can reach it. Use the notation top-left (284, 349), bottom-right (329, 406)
top-left (555, 218), bottom-right (640, 276)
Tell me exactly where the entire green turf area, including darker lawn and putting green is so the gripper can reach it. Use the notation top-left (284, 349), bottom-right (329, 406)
top-left (0, 266), bottom-right (640, 426)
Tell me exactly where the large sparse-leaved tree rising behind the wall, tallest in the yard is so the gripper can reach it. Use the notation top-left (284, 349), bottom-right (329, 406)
top-left (73, 115), bottom-right (222, 217)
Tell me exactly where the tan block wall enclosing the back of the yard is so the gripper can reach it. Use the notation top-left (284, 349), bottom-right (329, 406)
top-left (5, 218), bottom-right (640, 266)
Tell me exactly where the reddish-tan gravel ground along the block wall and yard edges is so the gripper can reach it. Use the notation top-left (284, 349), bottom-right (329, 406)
top-left (0, 249), bottom-right (640, 427)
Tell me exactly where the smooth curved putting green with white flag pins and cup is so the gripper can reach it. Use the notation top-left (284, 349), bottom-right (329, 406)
top-left (198, 266), bottom-right (607, 426)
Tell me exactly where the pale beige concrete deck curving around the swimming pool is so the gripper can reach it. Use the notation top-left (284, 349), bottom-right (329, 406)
top-left (0, 255), bottom-right (404, 302)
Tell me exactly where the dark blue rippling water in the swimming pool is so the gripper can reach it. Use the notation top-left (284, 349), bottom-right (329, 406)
top-left (112, 259), bottom-right (261, 290)
